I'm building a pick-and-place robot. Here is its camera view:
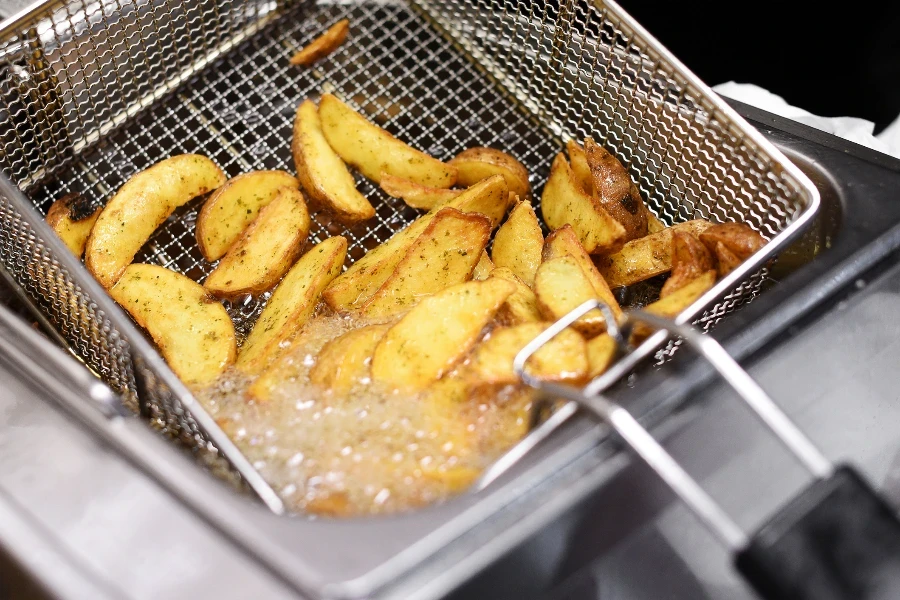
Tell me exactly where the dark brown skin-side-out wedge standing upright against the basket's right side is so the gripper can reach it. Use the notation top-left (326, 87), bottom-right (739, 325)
top-left (584, 138), bottom-right (647, 242)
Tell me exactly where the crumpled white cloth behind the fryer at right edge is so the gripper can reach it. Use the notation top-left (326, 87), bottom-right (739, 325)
top-left (713, 81), bottom-right (900, 158)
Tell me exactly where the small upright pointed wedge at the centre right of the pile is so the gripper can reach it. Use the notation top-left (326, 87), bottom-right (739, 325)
top-left (491, 202), bottom-right (544, 285)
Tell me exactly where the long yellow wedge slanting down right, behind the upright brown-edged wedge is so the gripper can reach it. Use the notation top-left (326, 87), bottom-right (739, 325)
top-left (319, 94), bottom-right (457, 188)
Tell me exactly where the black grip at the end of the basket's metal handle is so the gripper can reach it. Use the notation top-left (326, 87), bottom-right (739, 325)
top-left (735, 466), bottom-right (900, 600)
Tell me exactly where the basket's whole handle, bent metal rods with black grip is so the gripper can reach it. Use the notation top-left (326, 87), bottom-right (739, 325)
top-left (496, 301), bottom-right (900, 600)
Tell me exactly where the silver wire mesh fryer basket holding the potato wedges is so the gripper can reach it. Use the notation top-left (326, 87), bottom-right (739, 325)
top-left (0, 0), bottom-right (818, 510)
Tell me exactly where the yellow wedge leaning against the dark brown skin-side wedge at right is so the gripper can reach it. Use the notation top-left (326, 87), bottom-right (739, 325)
top-left (541, 153), bottom-right (625, 254)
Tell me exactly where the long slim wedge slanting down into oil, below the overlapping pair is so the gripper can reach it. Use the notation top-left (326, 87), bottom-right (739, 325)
top-left (237, 236), bottom-right (347, 374)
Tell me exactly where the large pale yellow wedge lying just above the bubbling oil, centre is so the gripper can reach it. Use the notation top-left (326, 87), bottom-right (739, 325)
top-left (372, 278), bottom-right (515, 392)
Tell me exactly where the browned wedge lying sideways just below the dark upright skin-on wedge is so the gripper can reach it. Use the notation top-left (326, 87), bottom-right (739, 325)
top-left (595, 219), bottom-right (712, 288)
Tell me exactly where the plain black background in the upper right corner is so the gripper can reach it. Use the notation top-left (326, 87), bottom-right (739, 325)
top-left (619, 0), bottom-right (900, 132)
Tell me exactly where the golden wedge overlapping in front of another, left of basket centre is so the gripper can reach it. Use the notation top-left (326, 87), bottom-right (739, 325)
top-left (203, 188), bottom-right (310, 298)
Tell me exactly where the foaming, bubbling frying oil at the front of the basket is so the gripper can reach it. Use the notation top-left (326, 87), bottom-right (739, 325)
top-left (196, 309), bottom-right (531, 516)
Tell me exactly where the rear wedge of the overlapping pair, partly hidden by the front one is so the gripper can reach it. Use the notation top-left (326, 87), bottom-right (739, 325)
top-left (197, 171), bottom-right (300, 262)
